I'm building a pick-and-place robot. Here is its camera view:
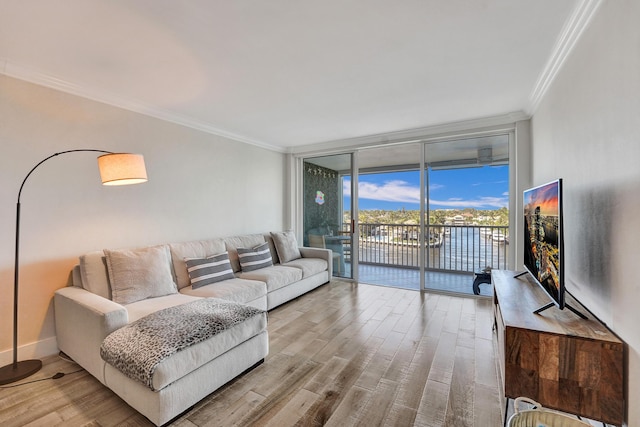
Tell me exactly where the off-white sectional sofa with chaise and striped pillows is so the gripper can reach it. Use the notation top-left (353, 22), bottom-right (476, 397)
top-left (54, 232), bottom-right (332, 425)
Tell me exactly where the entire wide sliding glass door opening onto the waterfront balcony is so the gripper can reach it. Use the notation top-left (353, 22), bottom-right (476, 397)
top-left (302, 133), bottom-right (512, 294)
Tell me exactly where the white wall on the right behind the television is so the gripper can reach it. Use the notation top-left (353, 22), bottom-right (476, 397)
top-left (532, 0), bottom-right (640, 426)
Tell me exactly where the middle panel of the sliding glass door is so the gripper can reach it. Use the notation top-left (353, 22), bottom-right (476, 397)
top-left (358, 143), bottom-right (424, 290)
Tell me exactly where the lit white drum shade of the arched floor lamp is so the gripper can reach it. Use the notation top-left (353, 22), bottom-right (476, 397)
top-left (98, 153), bottom-right (147, 185)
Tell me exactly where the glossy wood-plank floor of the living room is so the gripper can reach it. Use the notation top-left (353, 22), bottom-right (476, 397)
top-left (0, 280), bottom-right (502, 427)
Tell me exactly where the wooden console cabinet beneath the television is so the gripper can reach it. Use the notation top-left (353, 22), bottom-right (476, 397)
top-left (492, 270), bottom-right (625, 425)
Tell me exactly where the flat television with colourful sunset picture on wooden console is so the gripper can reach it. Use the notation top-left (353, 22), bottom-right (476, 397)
top-left (523, 179), bottom-right (565, 309)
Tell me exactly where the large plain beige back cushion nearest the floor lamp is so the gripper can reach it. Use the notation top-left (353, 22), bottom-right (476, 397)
top-left (104, 245), bottom-right (178, 304)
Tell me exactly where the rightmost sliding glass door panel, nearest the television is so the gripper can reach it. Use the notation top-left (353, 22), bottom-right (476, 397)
top-left (424, 134), bottom-right (510, 295)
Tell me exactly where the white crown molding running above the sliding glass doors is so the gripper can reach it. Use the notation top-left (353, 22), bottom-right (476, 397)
top-left (289, 111), bottom-right (531, 156)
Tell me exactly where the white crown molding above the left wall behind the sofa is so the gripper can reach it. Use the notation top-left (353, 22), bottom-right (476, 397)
top-left (0, 58), bottom-right (286, 153)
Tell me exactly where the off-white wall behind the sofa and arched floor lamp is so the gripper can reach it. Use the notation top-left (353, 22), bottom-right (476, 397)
top-left (0, 75), bottom-right (285, 365)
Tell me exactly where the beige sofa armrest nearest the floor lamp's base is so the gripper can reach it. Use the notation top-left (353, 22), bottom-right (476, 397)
top-left (53, 286), bottom-right (129, 383)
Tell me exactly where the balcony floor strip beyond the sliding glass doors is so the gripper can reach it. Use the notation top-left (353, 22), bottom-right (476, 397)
top-left (345, 263), bottom-right (493, 297)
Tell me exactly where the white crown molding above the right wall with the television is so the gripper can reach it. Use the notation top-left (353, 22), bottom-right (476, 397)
top-left (526, 0), bottom-right (604, 116)
